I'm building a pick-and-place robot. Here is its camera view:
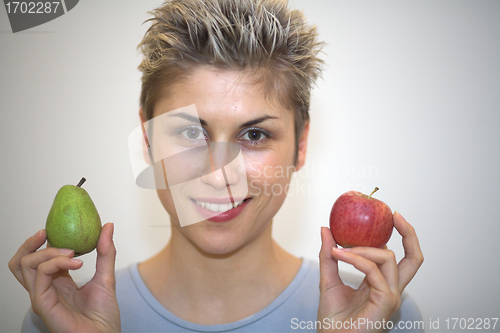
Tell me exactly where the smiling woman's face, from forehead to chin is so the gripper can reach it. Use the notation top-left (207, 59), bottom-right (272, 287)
top-left (145, 67), bottom-right (308, 254)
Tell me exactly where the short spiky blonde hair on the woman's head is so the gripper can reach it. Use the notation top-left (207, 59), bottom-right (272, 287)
top-left (139, 0), bottom-right (322, 162)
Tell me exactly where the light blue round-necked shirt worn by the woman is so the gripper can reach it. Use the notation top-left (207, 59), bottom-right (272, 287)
top-left (22, 260), bottom-right (423, 333)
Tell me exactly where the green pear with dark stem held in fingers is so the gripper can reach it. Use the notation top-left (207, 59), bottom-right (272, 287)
top-left (45, 178), bottom-right (102, 257)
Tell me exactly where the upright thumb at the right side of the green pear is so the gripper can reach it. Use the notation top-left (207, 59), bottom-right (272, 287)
top-left (94, 223), bottom-right (116, 290)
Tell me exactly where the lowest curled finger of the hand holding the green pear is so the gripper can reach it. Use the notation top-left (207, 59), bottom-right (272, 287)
top-left (32, 256), bottom-right (83, 311)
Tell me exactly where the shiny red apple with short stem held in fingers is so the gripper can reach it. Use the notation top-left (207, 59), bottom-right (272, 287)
top-left (330, 187), bottom-right (394, 248)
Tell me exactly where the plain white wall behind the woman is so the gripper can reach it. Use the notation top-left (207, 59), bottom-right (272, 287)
top-left (0, 0), bottom-right (500, 332)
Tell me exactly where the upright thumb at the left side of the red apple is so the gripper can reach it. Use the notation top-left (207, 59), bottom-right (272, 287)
top-left (319, 227), bottom-right (343, 291)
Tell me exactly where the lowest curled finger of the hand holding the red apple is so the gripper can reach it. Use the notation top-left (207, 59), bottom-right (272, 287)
top-left (332, 248), bottom-right (397, 311)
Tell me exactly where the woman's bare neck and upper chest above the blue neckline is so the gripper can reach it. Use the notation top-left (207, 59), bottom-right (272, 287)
top-left (140, 219), bottom-right (300, 324)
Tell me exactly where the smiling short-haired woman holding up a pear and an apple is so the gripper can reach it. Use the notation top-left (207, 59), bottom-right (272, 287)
top-left (9, 0), bottom-right (423, 332)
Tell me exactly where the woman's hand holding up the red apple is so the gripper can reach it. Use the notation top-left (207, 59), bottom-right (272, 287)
top-left (318, 213), bottom-right (424, 332)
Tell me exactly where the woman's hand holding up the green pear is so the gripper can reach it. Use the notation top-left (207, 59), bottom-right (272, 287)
top-left (9, 223), bottom-right (120, 332)
